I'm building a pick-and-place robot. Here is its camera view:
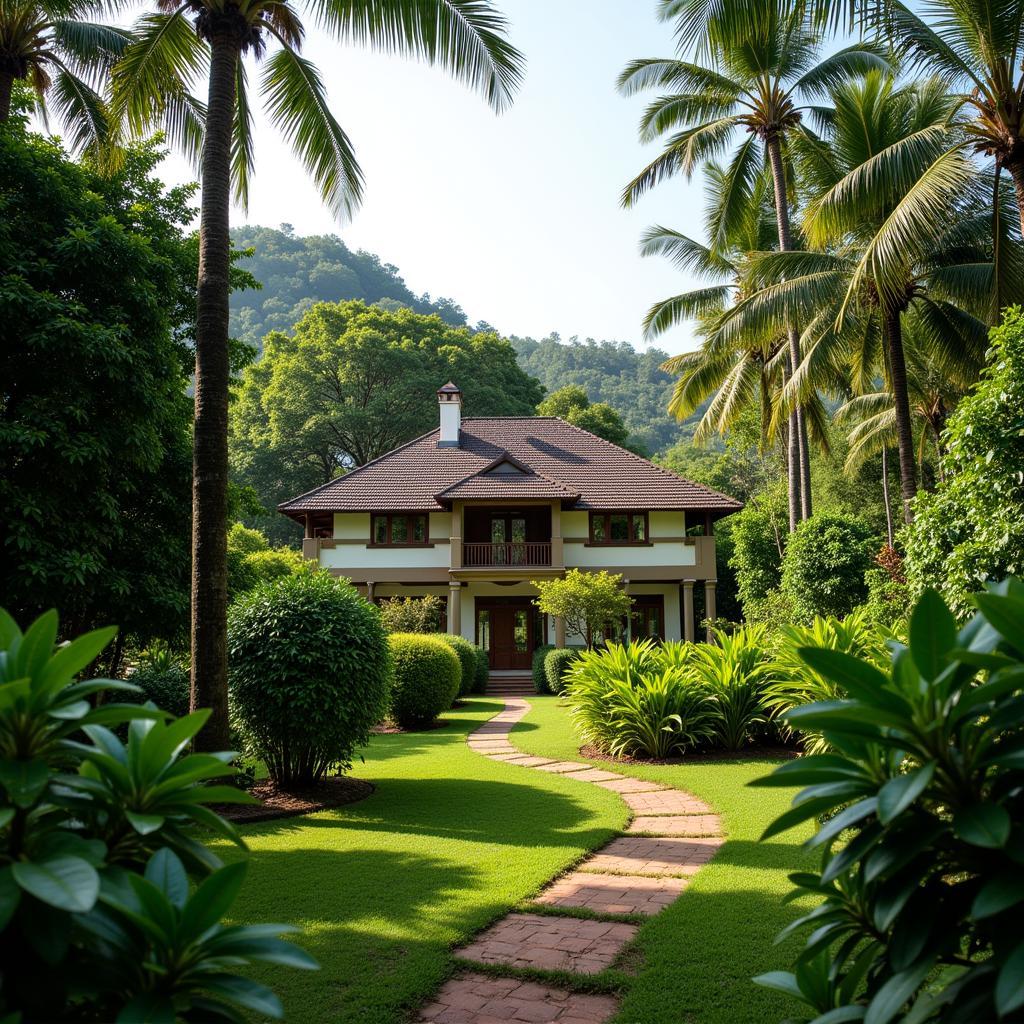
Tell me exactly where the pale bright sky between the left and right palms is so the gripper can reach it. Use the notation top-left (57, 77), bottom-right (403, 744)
top-left (155, 0), bottom-right (703, 352)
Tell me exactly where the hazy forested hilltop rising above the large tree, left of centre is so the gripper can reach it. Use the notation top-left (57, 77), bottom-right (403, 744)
top-left (230, 224), bottom-right (466, 349)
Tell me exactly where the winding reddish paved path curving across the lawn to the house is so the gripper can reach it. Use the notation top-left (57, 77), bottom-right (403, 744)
top-left (419, 696), bottom-right (724, 1024)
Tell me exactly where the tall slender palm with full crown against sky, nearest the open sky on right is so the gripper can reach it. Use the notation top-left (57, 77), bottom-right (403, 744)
top-left (618, 0), bottom-right (888, 528)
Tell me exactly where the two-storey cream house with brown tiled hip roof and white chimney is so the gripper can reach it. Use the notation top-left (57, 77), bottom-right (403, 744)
top-left (279, 383), bottom-right (741, 672)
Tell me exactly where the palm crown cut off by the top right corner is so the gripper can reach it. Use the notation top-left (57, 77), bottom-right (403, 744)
top-left (872, 0), bottom-right (1024, 233)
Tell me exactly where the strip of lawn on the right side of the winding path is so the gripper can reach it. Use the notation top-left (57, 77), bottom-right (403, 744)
top-left (512, 697), bottom-right (811, 1024)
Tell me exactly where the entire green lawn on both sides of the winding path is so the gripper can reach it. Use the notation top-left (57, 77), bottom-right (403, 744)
top-left (221, 697), bottom-right (815, 1024)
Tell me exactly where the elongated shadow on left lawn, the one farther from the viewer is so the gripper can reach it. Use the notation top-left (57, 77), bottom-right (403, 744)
top-left (235, 776), bottom-right (614, 848)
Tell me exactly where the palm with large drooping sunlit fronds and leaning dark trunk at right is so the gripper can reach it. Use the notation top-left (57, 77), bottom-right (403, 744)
top-left (716, 72), bottom-right (995, 521)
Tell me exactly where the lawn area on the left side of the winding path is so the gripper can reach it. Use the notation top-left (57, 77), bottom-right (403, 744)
top-left (210, 698), bottom-right (627, 1024)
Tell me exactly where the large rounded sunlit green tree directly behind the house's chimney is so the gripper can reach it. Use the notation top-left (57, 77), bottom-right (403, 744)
top-left (231, 301), bottom-right (542, 539)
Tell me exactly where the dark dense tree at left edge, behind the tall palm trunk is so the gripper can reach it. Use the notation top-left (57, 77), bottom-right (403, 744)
top-left (0, 120), bottom-right (196, 638)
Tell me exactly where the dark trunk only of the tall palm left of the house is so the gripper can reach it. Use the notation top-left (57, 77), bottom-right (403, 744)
top-left (190, 29), bottom-right (241, 751)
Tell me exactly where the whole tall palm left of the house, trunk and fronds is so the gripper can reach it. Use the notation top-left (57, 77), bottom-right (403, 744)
top-left (113, 0), bottom-right (522, 749)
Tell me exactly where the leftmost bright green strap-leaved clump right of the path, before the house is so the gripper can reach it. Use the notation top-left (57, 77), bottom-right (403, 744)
top-left (561, 640), bottom-right (714, 758)
